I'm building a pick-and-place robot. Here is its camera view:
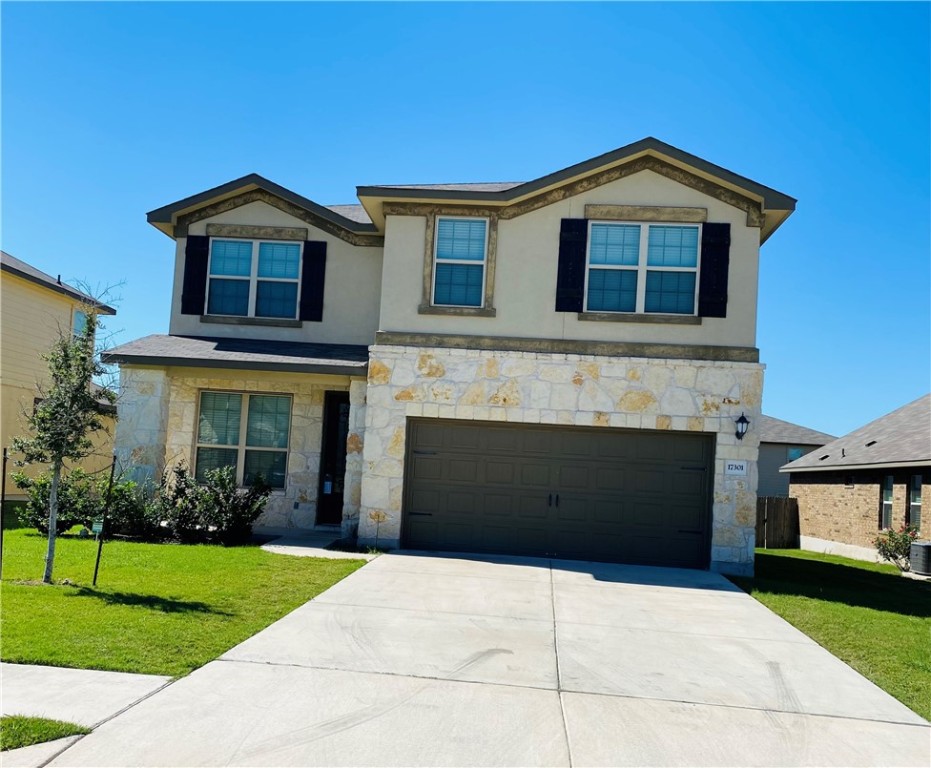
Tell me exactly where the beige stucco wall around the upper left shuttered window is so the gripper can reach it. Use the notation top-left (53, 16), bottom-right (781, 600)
top-left (169, 202), bottom-right (382, 344)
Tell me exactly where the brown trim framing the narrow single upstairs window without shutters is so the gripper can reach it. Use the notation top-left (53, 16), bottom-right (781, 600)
top-left (417, 206), bottom-right (498, 317)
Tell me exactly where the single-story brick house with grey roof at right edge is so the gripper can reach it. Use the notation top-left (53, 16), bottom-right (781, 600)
top-left (782, 394), bottom-right (931, 558)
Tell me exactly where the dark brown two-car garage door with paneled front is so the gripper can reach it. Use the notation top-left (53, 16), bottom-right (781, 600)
top-left (403, 419), bottom-right (713, 568)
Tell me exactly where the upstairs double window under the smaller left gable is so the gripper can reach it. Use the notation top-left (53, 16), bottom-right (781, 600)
top-left (207, 238), bottom-right (301, 320)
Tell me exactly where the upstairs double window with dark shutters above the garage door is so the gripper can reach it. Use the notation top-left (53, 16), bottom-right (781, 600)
top-left (585, 222), bottom-right (701, 315)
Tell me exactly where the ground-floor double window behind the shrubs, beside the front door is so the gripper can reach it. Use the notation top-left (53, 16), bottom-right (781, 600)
top-left (194, 392), bottom-right (291, 488)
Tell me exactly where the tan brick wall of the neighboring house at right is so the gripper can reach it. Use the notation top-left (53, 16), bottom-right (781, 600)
top-left (789, 468), bottom-right (931, 549)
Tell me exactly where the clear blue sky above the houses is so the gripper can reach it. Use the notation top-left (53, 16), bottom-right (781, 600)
top-left (0, 2), bottom-right (931, 435)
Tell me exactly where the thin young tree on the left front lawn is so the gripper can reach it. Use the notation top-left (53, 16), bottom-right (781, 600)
top-left (12, 306), bottom-right (116, 584)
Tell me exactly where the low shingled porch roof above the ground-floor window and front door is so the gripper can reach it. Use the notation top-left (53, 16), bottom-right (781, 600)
top-left (103, 334), bottom-right (368, 375)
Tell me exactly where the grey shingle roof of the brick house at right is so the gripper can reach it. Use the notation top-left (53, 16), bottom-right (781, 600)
top-left (780, 394), bottom-right (931, 472)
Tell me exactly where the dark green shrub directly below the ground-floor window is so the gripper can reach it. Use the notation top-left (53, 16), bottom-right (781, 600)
top-left (148, 464), bottom-right (271, 545)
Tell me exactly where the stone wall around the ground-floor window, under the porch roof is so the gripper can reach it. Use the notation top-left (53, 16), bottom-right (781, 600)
top-left (117, 367), bottom-right (351, 528)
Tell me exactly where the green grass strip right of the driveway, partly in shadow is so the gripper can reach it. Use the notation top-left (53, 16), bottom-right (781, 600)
top-left (733, 549), bottom-right (931, 719)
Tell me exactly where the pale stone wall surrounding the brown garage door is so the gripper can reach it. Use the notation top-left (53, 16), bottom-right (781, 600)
top-left (359, 345), bottom-right (763, 573)
